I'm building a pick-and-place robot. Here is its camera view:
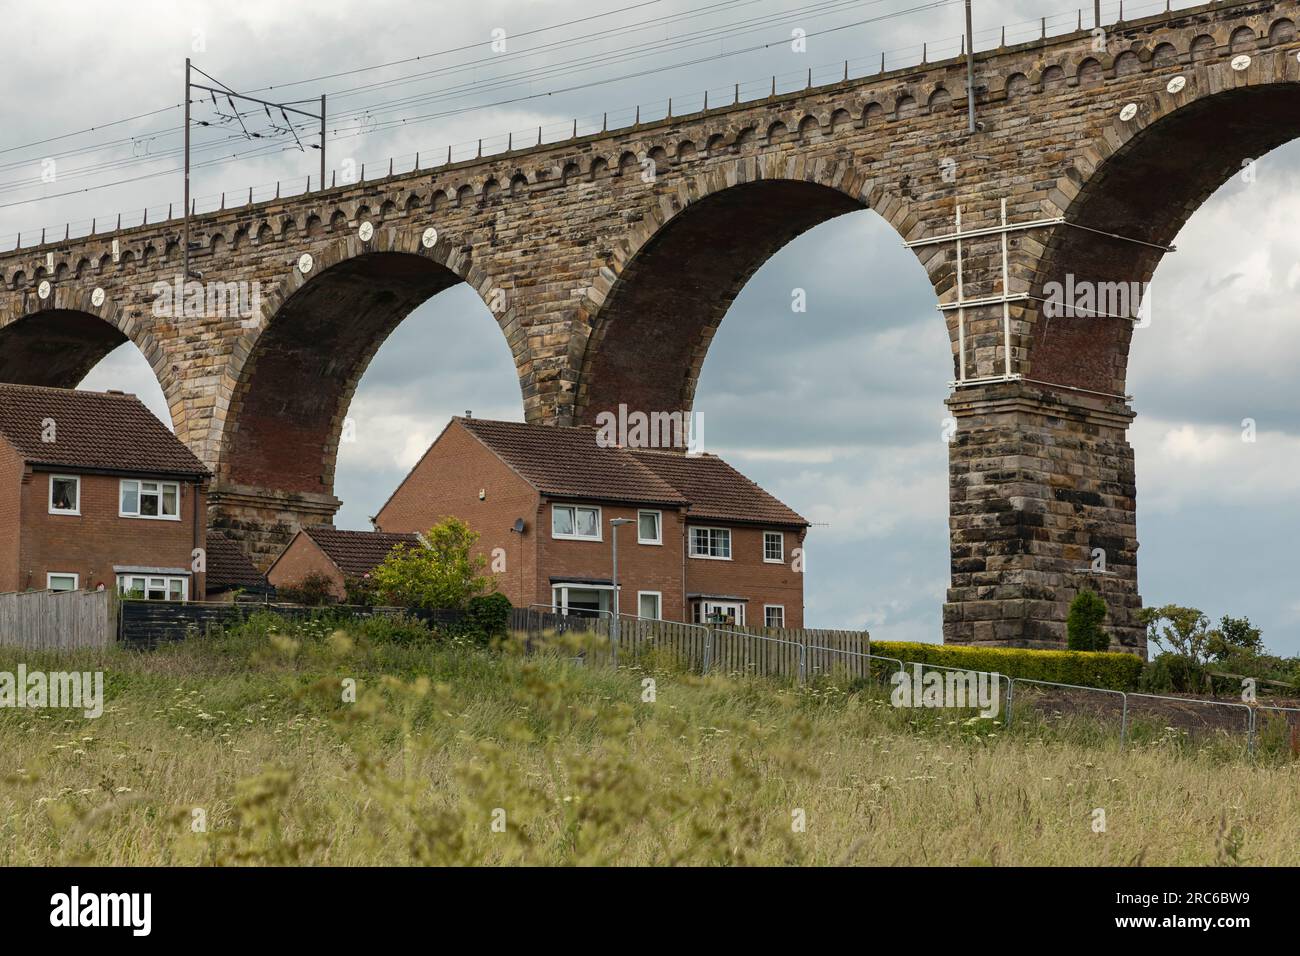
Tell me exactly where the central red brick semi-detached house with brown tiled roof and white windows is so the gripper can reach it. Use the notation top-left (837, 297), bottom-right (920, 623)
top-left (373, 418), bottom-right (807, 627)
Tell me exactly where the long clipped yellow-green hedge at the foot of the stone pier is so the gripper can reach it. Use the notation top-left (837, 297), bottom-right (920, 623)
top-left (871, 641), bottom-right (1143, 691)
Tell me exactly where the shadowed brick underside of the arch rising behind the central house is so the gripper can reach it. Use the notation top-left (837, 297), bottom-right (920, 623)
top-left (576, 179), bottom-right (863, 423)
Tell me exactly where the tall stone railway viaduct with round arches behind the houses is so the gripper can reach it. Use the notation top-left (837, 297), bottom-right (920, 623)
top-left (0, 0), bottom-right (1300, 653)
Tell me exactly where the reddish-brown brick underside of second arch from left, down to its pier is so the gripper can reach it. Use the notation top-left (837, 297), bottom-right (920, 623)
top-left (212, 251), bottom-right (519, 566)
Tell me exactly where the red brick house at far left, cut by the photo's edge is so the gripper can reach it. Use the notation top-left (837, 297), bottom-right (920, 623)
top-left (0, 385), bottom-right (209, 601)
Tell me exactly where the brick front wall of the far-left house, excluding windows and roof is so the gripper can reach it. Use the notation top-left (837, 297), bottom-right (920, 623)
top-left (9, 466), bottom-right (207, 601)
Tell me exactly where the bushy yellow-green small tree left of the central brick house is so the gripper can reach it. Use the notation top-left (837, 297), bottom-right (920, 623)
top-left (373, 518), bottom-right (497, 610)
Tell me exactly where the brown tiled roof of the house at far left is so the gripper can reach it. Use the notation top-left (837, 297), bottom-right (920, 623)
top-left (0, 385), bottom-right (208, 477)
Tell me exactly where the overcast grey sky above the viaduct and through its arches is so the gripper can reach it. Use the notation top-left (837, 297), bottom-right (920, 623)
top-left (0, 0), bottom-right (1300, 654)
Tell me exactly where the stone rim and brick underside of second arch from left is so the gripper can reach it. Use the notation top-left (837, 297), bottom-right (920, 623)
top-left (215, 225), bottom-right (528, 515)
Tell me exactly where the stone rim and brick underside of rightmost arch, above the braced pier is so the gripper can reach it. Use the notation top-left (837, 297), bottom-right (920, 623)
top-left (1022, 56), bottom-right (1300, 395)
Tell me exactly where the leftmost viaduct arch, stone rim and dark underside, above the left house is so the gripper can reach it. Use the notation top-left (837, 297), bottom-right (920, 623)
top-left (0, 284), bottom-right (176, 421)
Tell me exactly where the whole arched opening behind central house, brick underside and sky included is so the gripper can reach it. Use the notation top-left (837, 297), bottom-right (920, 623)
top-left (579, 181), bottom-right (953, 641)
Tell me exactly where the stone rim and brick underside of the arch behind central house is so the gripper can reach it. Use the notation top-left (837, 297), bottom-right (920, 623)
top-left (574, 153), bottom-right (930, 424)
